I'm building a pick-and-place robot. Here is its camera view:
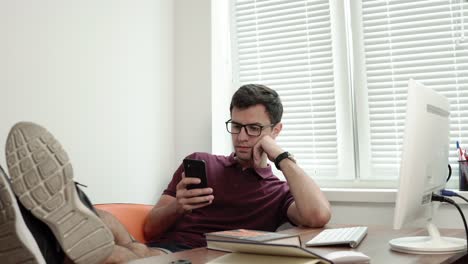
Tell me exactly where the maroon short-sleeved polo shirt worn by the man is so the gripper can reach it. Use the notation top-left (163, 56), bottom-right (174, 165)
top-left (155, 153), bottom-right (294, 247)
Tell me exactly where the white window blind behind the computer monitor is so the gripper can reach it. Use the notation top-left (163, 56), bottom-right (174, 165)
top-left (354, 0), bottom-right (468, 182)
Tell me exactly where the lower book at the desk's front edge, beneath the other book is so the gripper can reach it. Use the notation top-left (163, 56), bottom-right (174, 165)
top-left (207, 240), bottom-right (333, 264)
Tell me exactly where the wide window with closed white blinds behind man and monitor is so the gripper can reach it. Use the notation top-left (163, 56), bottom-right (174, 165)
top-left (232, 0), bottom-right (468, 187)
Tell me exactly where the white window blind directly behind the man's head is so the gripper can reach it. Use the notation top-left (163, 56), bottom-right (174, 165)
top-left (233, 0), bottom-right (352, 178)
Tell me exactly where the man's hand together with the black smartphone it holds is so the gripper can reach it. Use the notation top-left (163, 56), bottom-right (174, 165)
top-left (176, 159), bottom-right (214, 213)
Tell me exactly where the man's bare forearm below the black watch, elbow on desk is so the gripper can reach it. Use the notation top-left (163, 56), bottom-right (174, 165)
top-left (280, 159), bottom-right (331, 227)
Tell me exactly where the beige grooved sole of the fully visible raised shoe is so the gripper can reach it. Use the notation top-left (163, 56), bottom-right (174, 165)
top-left (6, 122), bottom-right (114, 264)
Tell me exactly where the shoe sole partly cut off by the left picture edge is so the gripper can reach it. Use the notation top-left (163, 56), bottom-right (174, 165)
top-left (0, 171), bottom-right (46, 264)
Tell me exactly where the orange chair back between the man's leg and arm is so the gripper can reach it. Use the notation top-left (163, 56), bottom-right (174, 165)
top-left (94, 203), bottom-right (153, 243)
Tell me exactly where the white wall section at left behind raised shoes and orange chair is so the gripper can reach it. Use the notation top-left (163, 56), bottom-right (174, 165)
top-left (0, 0), bottom-right (175, 203)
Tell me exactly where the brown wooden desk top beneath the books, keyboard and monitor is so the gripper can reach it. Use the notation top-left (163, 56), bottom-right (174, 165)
top-left (131, 226), bottom-right (465, 264)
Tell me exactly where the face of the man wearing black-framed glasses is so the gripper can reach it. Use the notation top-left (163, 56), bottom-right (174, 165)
top-left (231, 104), bottom-right (277, 161)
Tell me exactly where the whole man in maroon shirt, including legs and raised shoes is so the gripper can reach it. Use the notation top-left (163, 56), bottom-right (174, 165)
top-left (0, 85), bottom-right (330, 264)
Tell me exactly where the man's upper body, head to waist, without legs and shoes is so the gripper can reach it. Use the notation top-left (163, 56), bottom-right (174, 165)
top-left (144, 84), bottom-right (331, 251)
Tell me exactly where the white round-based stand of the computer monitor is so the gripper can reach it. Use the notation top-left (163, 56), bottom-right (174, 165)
top-left (389, 222), bottom-right (466, 254)
